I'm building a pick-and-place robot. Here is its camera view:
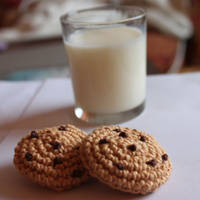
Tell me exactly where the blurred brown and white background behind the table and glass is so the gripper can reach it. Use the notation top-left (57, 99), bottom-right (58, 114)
top-left (0, 0), bottom-right (200, 80)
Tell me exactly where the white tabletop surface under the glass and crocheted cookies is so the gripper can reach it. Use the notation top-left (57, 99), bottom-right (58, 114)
top-left (0, 73), bottom-right (200, 200)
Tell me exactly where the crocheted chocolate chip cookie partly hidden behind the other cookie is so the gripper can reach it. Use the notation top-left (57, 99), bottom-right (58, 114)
top-left (14, 125), bottom-right (88, 191)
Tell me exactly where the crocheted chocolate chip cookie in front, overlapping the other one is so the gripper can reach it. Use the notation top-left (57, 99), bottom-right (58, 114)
top-left (80, 126), bottom-right (172, 194)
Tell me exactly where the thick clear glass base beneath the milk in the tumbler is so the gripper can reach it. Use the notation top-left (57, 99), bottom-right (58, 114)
top-left (74, 102), bottom-right (145, 125)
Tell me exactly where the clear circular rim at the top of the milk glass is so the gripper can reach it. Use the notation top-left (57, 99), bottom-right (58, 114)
top-left (60, 5), bottom-right (146, 26)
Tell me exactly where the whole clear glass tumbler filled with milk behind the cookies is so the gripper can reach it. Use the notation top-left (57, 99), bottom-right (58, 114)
top-left (61, 5), bottom-right (146, 124)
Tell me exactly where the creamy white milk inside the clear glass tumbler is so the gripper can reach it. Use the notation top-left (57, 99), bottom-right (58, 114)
top-left (65, 25), bottom-right (146, 114)
